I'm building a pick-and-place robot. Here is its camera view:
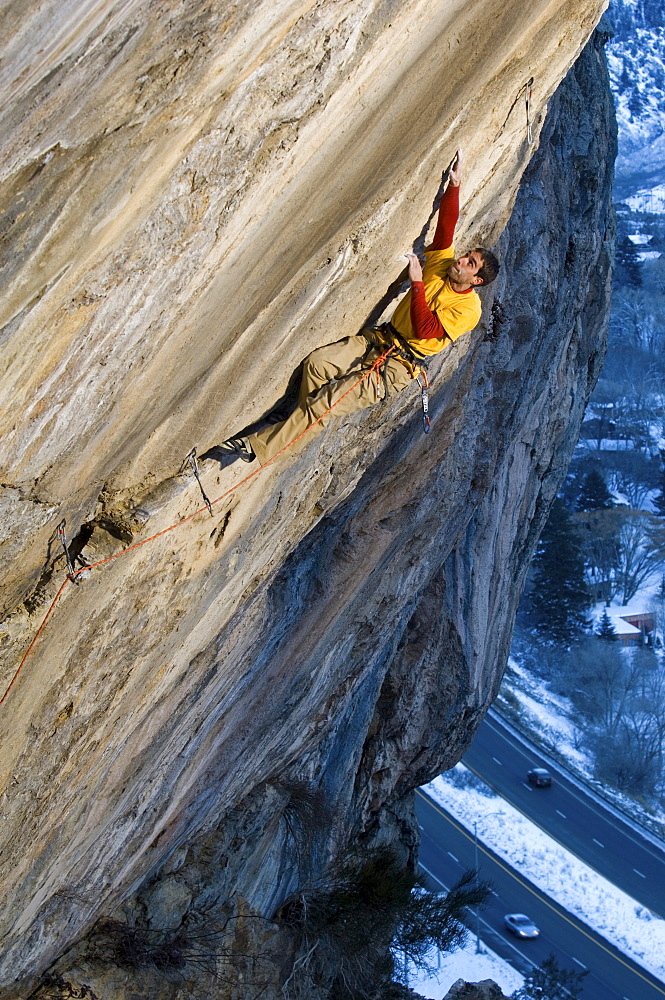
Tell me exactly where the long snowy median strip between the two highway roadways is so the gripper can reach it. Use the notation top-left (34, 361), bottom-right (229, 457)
top-left (424, 764), bottom-right (665, 982)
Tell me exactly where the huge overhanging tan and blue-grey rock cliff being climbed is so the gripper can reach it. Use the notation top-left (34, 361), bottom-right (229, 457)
top-left (0, 0), bottom-right (615, 1000)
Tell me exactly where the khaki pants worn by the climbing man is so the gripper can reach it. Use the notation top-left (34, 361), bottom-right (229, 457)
top-left (246, 334), bottom-right (414, 465)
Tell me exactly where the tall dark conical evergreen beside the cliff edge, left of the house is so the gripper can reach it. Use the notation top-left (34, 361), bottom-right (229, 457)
top-left (530, 497), bottom-right (590, 643)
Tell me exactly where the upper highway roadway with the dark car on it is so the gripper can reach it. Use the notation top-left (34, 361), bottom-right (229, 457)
top-left (463, 715), bottom-right (665, 916)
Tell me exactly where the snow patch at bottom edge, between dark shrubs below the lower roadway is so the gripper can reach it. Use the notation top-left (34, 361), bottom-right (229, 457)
top-left (409, 938), bottom-right (524, 1000)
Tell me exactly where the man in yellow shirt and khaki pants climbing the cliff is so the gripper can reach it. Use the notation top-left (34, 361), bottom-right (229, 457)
top-left (207, 151), bottom-right (499, 465)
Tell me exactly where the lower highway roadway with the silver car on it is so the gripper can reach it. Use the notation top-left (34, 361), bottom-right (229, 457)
top-left (416, 789), bottom-right (665, 1000)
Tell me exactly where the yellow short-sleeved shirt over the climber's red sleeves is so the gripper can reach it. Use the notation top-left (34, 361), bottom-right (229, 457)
top-left (390, 245), bottom-right (481, 356)
